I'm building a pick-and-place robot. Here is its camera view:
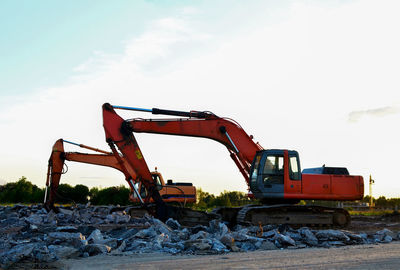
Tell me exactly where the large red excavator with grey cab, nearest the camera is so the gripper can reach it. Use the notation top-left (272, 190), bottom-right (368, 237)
top-left (103, 103), bottom-right (364, 227)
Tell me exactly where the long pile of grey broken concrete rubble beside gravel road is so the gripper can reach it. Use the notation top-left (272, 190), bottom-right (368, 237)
top-left (0, 205), bottom-right (400, 268)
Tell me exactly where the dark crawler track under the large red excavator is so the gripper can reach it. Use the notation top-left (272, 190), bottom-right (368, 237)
top-left (236, 204), bottom-right (351, 227)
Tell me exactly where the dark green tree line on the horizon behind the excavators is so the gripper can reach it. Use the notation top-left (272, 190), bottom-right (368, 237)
top-left (0, 176), bottom-right (400, 210)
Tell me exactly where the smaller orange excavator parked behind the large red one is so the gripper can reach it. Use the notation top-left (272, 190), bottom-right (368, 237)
top-left (44, 139), bottom-right (196, 209)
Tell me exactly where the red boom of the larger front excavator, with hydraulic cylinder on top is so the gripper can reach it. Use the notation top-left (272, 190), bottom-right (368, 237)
top-left (103, 104), bottom-right (263, 186)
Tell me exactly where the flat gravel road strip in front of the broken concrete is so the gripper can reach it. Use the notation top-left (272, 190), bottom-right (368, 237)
top-left (54, 242), bottom-right (400, 270)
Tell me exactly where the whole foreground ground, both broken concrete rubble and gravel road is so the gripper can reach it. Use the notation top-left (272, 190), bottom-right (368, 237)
top-left (0, 205), bottom-right (400, 270)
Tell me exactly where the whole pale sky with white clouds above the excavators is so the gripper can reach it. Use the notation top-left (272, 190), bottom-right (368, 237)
top-left (0, 0), bottom-right (400, 197)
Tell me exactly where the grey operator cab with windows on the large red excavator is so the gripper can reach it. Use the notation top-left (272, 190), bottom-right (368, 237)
top-left (250, 149), bottom-right (301, 200)
